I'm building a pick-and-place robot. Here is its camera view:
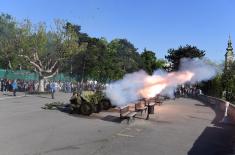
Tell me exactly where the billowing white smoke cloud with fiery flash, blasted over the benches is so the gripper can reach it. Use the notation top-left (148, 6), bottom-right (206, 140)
top-left (105, 58), bottom-right (217, 106)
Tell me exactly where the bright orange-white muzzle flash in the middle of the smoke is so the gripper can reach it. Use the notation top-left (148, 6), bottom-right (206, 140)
top-left (139, 71), bottom-right (194, 98)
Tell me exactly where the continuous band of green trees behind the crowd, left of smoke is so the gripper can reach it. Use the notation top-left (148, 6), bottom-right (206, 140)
top-left (0, 14), bottom-right (171, 85)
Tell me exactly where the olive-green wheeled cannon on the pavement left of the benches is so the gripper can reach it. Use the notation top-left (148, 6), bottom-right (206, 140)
top-left (70, 91), bottom-right (112, 116)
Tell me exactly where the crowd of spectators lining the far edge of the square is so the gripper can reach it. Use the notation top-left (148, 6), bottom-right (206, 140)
top-left (0, 79), bottom-right (202, 98)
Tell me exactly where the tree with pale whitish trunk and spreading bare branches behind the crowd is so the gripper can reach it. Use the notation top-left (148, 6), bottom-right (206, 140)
top-left (18, 20), bottom-right (86, 91)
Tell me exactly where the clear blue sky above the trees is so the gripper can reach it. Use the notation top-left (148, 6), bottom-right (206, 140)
top-left (0, 0), bottom-right (235, 63)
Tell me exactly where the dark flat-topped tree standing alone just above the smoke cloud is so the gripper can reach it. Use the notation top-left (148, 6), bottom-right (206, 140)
top-left (165, 45), bottom-right (205, 71)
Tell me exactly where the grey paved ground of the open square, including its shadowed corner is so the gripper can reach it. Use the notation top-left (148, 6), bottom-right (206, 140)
top-left (0, 93), bottom-right (235, 155)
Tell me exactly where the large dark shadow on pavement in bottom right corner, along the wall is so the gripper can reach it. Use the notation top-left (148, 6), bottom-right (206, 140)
top-left (188, 98), bottom-right (235, 155)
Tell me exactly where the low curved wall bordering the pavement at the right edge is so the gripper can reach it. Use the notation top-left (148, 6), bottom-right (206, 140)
top-left (197, 95), bottom-right (235, 124)
